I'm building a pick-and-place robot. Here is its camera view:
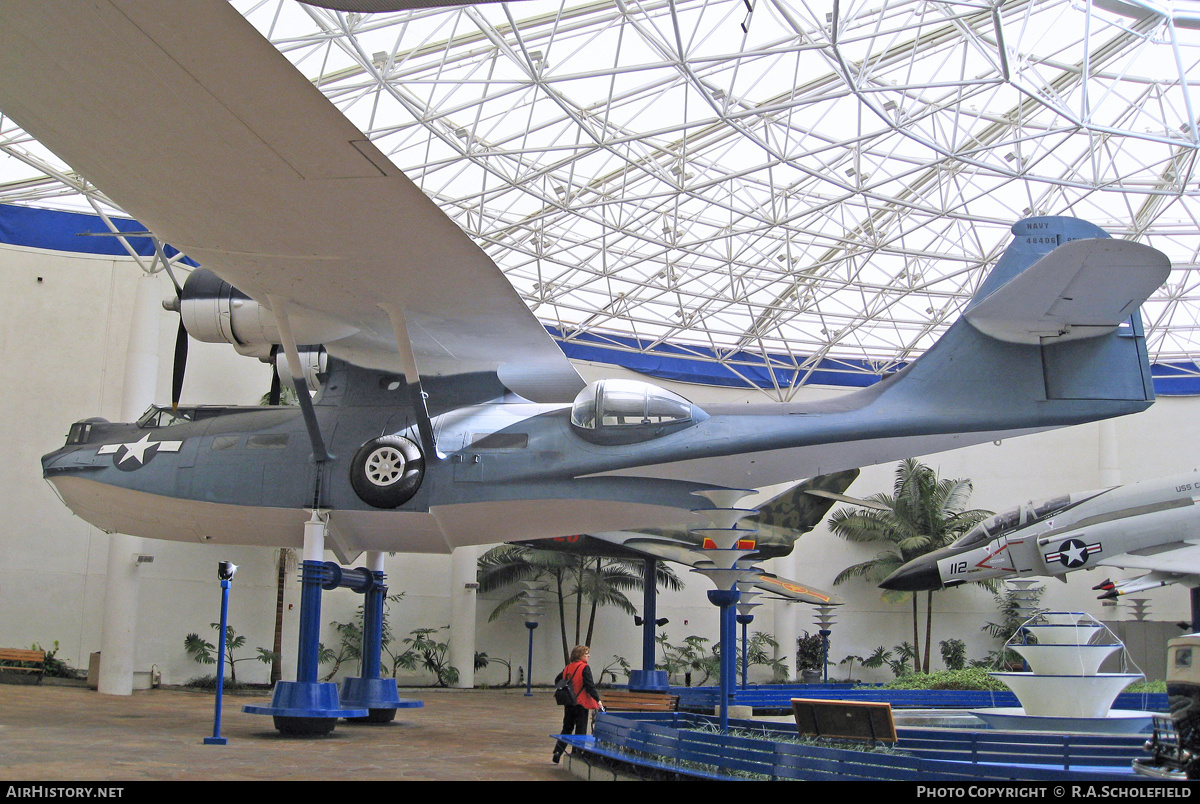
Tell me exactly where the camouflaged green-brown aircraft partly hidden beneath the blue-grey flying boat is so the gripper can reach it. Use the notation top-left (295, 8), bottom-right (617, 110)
top-left (518, 469), bottom-right (870, 606)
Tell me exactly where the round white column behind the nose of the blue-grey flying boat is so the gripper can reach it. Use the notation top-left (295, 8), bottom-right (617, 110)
top-left (97, 274), bottom-right (162, 695)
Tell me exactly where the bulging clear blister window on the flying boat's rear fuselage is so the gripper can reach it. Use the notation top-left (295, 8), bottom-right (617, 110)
top-left (571, 379), bottom-right (707, 443)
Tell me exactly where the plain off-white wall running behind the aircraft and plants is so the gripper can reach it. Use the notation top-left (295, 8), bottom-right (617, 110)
top-left (0, 246), bottom-right (1200, 684)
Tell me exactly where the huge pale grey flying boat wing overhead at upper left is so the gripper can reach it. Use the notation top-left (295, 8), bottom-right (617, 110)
top-left (0, 0), bottom-right (583, 402)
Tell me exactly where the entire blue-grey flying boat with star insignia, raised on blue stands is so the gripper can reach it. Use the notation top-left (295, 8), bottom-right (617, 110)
top-left (9, 0), bottom-right (1170, 561)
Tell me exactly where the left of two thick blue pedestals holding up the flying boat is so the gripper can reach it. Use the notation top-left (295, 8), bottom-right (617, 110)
top-left (242, 562), bottom-right (371, 737)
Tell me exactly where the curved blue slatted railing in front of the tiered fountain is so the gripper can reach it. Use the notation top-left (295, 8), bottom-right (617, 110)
top-left (562, 713), bottom-right (1144, 781)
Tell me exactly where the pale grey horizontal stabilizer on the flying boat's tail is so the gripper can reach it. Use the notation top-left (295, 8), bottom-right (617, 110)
top-left (964, 238), bottom-right (1171, 344)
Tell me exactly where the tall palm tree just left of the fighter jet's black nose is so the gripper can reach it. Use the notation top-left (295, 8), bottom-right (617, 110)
top-left (829, 458), bottom-right (991, 673)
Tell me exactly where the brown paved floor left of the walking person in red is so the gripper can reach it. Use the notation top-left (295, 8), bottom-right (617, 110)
top-left (0, 683), bottom-right (574, 782)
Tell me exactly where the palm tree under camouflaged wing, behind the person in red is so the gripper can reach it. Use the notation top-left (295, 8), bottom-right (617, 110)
top-left (479, 545), bottom-right (683, 662)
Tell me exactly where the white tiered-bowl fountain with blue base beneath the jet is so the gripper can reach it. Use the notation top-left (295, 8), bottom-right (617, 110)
top-left (971, 612), bottom-right (1152, 733)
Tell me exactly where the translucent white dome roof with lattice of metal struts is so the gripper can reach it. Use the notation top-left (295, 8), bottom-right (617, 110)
top-left (0, 0), bottom-right (1200, 398)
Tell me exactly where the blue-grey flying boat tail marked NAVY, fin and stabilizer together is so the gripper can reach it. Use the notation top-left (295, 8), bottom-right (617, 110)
top-left (877, 217), bottom-right (1170, 424)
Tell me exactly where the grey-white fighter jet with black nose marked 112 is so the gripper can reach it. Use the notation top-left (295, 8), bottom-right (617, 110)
top-left (881, 473), bottom-right (1200, 600)
